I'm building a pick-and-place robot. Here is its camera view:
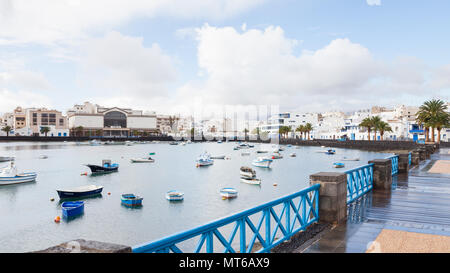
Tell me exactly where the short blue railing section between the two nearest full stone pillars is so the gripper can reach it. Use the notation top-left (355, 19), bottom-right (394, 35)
top-left (345, 163), bottom-right (374, 204)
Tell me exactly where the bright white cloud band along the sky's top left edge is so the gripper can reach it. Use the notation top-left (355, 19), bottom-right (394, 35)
top-left (0, 0), bottom-right (265, 44)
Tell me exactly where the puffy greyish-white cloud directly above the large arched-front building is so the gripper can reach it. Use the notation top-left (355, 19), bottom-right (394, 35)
top-left (79, 31), bottom-right (177, 98)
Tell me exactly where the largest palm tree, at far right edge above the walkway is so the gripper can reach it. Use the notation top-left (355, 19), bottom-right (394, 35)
top-left (416, 99), bottom-right (447, 142)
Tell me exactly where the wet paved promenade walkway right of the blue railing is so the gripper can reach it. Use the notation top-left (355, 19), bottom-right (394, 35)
top-left (294, 149), bottom-right (450, 253)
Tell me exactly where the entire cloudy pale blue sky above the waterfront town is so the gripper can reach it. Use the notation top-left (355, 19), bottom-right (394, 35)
top-left (0, 0), bottom-right (450, 114)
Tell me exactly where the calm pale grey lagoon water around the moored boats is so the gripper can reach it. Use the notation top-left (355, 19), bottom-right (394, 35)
top-left (0, 142), bottom-right (390, 252)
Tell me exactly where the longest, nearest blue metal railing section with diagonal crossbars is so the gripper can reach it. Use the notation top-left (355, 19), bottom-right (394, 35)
top-left (133, 184), bottom-right (320, 253)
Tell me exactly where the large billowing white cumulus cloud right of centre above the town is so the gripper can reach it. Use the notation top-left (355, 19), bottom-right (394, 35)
top-left (174, 25), bottom-right (382, 110)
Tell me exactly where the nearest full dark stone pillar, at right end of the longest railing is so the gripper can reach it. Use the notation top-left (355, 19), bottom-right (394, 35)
top-left (309, 172), bottom-right (347, 224)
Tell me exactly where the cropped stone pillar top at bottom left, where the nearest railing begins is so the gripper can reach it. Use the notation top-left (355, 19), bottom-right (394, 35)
top-left (34, 239), bottom-right (132, 253)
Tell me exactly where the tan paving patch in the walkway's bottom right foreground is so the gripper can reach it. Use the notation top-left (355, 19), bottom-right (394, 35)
top-left (366, 229), bottom-right (450, 253)
